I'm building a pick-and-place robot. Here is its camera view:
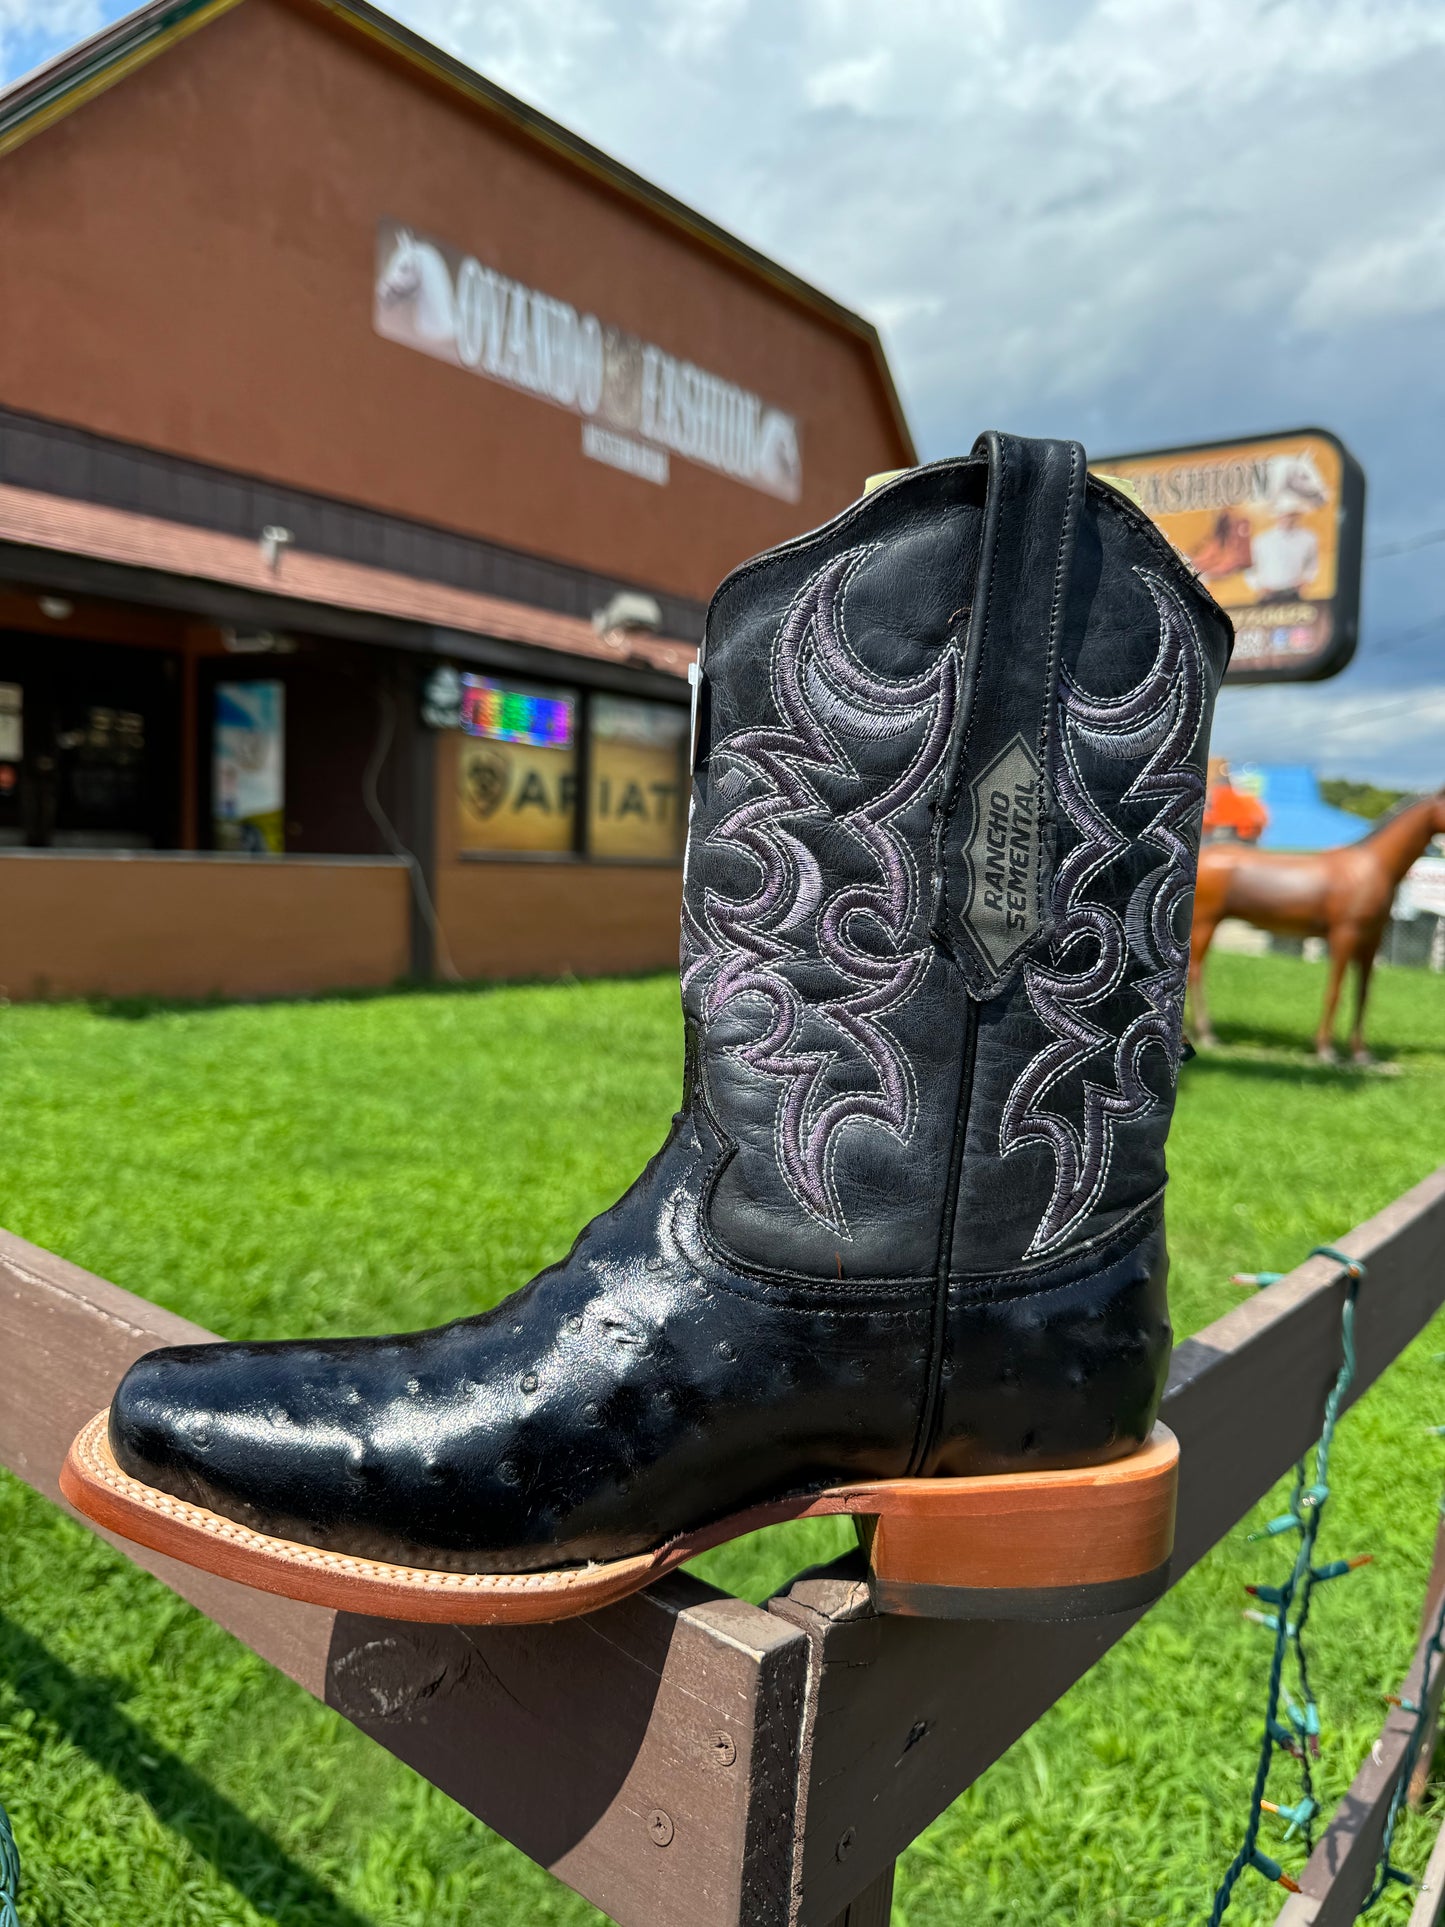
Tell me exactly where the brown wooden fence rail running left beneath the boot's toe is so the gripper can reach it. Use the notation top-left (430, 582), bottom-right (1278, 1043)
top-left (0, 1233), bottom-right (805, 1927)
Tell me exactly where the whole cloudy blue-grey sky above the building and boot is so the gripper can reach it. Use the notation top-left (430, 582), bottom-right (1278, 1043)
top-left (0, 0), bottom-right (1445, 786)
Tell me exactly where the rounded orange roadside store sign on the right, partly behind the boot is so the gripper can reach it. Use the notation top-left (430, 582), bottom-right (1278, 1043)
top-left (1092, 428), bottom-right (1364, 682)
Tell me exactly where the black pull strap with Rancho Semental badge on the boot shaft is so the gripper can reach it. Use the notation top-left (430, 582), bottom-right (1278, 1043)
top-left (934, 432), bottom-right (1087, 998)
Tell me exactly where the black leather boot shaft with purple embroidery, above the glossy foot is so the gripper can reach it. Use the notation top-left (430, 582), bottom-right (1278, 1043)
top-left (684, 436), bottom-right (1229, 1280)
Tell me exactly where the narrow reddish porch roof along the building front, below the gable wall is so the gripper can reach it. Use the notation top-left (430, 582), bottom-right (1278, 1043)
top-left (0, 486), bottom-right (697, 676)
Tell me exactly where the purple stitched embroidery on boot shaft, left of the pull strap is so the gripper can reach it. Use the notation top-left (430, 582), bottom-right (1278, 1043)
top-left (682, 549), bottom-right (958, 1237)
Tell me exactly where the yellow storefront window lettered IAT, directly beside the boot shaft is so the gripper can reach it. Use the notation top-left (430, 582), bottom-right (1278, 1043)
top-left (588, 696), bottom-right (688, 861)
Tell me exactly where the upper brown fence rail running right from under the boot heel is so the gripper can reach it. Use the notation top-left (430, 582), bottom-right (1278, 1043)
top-left (771, 1170), bottom-right (1445, 1927)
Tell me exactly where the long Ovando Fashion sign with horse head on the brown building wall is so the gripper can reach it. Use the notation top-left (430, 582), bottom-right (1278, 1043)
top-left (372, 222), bottom-right (803, 501)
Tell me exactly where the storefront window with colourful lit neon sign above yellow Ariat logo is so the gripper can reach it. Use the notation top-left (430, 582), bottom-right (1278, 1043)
top-left (457, 676), bottom-right (578, 854)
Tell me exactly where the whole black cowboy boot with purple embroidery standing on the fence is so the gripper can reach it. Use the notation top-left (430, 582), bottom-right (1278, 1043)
top-left (66, 436), bottom-right (1229, 1621)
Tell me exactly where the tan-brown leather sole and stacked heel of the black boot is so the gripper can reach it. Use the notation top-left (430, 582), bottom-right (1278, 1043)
top-left (60, 1412), bottom-right (1179, 1626)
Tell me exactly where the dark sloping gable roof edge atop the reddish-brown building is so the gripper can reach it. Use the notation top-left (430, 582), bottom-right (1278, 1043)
top-left (0, 0), bottom-right (917, 461)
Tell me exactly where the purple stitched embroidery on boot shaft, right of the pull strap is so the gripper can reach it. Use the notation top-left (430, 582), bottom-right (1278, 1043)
top-left (998, 568), bottom-right (1204, 1256)
